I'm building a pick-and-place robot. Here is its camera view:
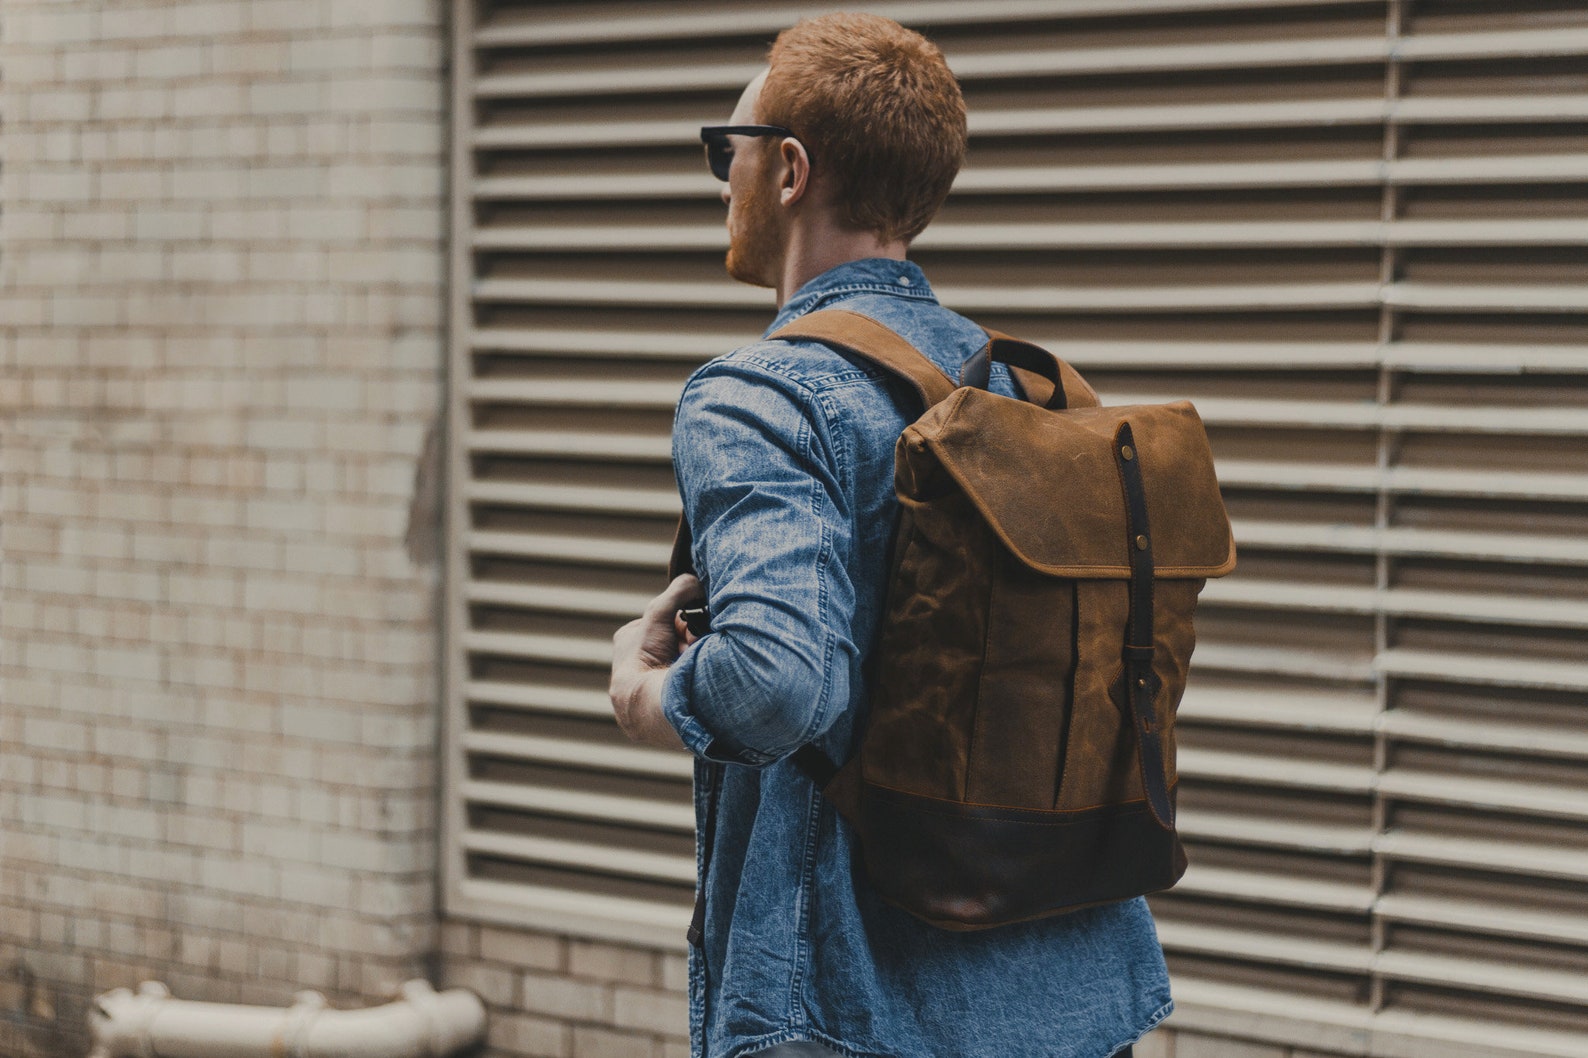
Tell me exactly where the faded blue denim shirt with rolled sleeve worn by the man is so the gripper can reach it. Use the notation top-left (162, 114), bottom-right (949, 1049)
top-left (662, 259), bottom-right (1172, 1058)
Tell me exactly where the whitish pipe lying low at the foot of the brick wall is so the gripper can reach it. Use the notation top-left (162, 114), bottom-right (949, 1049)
top-left (89, 979), bottom-right (486, 1058)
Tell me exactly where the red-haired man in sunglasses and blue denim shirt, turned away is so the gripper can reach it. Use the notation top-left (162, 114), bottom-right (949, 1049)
top-left (611, 14), bottom-right (1172, 1058)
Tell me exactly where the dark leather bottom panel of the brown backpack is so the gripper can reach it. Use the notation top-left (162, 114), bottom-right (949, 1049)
top-left (859, 783), bottom-right (1186, 929)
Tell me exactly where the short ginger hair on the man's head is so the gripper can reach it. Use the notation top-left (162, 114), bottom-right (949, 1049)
top-left (757, 14), bottom-right (966, 241)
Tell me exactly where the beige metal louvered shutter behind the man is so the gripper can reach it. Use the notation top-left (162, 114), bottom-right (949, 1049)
top-left (445, 0), bottom-right (1588, 1055)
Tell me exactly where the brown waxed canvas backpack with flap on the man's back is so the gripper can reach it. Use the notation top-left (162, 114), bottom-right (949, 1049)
top-left (673, 310), bottom-right (1235, 929)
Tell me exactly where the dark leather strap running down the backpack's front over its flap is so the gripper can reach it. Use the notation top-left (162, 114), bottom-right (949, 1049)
top-left (1113, 423), bottom-right (1175, 829)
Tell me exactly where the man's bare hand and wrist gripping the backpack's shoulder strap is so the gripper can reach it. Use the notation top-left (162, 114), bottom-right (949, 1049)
top-left (608, 573), bottom-right (700, 750)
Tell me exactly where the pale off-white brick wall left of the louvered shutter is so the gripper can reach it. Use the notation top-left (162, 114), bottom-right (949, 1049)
top-left (0, 0), bottom-right (446, 1058)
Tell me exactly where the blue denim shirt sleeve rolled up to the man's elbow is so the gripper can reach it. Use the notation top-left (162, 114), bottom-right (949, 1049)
top-left (662, 359), bottom-right (856, 766)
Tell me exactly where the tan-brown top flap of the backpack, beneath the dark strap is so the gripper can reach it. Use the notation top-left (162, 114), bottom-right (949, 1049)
top-left (897, 388), bottom-right (1235, 580)
